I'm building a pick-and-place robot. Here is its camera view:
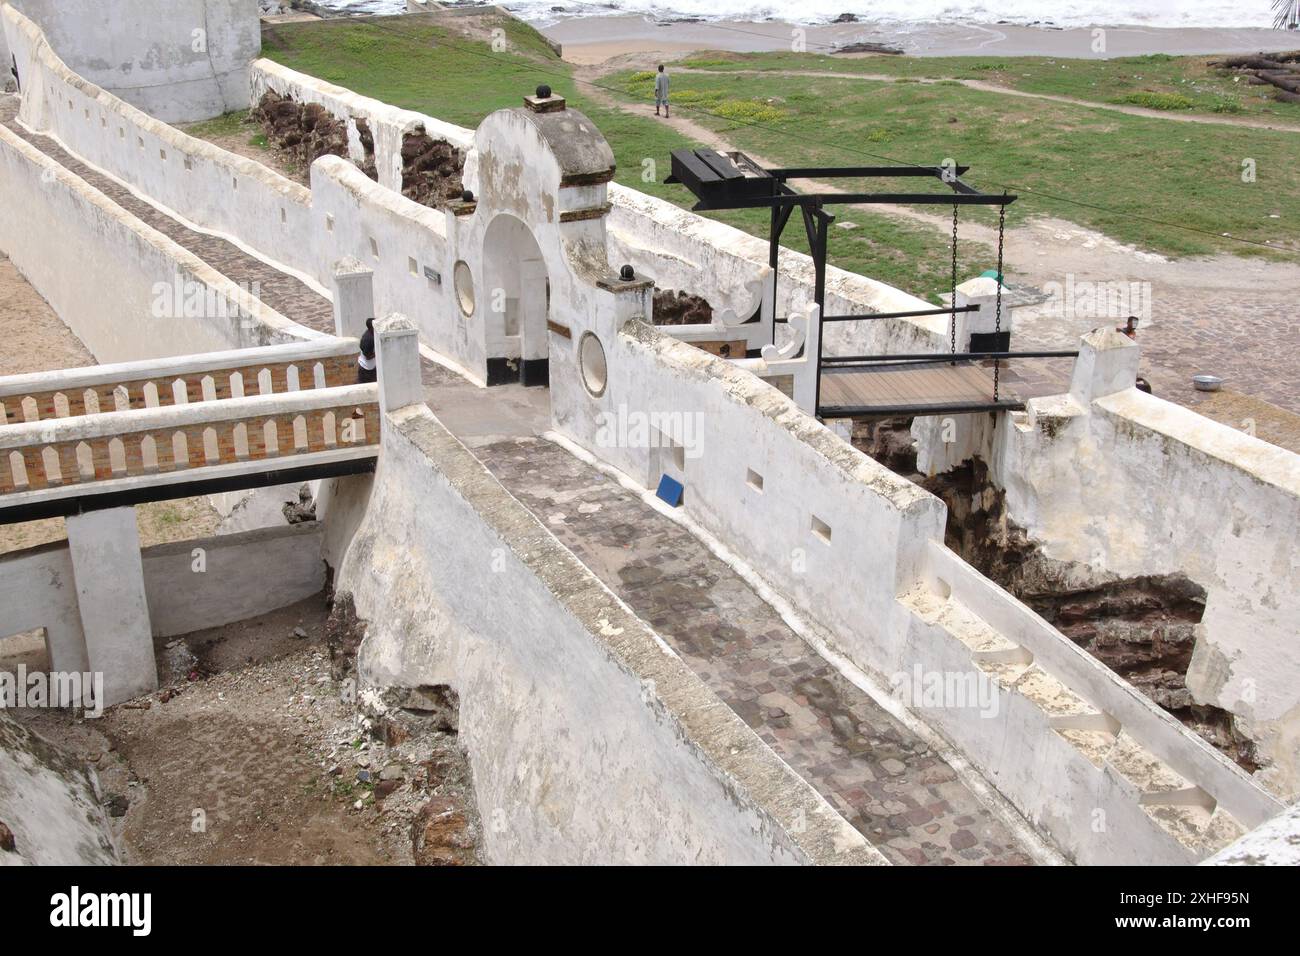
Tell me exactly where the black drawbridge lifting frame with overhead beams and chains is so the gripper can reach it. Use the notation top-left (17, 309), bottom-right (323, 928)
top-left (664, 150), bottom-right (1055, 415)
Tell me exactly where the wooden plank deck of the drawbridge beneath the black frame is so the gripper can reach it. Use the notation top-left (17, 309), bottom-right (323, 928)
top-left (818, 362), bottom-right (1024, 418)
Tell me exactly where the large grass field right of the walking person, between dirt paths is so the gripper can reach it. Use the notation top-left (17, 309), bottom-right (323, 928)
top-left (608, 61), bottom-right (1300, 255)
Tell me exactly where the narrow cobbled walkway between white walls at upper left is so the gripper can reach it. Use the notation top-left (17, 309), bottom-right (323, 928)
top-left (0, 96), bottom-right (334, 332)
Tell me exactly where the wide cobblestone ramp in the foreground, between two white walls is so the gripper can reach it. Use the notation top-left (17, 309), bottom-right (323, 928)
top-left (475, 438), bottom-right (1031, 865)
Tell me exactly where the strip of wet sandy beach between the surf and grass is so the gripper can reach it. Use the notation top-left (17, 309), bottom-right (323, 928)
top-left (537, 16), bottom-right (1300, 64)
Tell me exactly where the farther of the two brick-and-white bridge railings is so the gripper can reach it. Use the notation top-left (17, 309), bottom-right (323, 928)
top-left (0, 338), bottom-right (358, 425)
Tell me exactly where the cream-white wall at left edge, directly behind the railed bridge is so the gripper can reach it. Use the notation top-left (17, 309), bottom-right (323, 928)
top-left (0, 121), bottom-right (316, 362)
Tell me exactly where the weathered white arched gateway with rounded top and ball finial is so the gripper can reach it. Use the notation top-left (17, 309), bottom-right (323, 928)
top-left (449, 87), bottom-right (653, 403)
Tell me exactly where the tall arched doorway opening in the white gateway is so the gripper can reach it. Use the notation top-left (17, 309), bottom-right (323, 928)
top-left (482, 213), bottom-right (550, 385)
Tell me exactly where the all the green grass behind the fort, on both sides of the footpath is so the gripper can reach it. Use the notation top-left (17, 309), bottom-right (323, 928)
top-left (263, 18), bottom-right (1300, 300)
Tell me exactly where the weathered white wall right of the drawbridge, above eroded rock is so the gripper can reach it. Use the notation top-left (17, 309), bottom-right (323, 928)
top-left (984, 388), bottom-right (1300, 797)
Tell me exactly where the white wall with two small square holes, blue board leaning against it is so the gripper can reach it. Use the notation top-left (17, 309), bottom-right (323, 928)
top-left (556, 321), bottom-right (944, 649)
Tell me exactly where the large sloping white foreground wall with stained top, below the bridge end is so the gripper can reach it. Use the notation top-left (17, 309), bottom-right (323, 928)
top-left (337, 403), bottom-right (883, 864)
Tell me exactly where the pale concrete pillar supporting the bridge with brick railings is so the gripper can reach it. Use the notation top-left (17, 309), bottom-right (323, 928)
top-left (68, 507), bottom-right (159, 706)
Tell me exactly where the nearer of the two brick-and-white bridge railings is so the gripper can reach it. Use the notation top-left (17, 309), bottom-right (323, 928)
top-left (0, 384), bottom-right (380, 497)
